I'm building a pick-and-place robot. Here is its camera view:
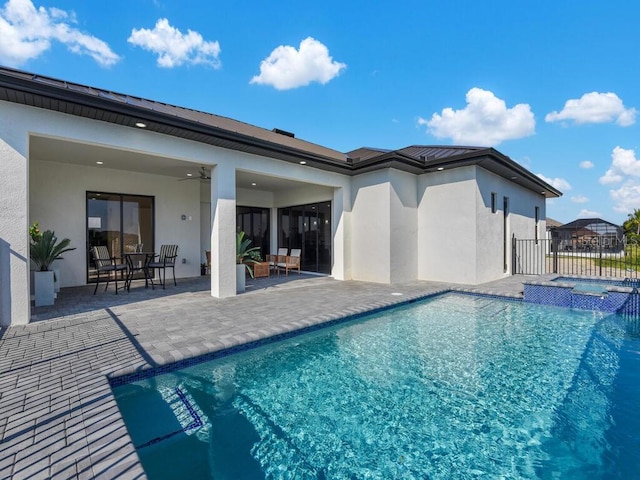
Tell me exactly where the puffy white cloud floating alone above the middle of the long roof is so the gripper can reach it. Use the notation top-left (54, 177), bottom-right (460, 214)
top-left (249, 37), bottom-right (347, 90)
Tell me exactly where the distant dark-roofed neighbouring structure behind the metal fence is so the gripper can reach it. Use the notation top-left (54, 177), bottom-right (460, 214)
top-left (551, 218), bottom-right (624, 253)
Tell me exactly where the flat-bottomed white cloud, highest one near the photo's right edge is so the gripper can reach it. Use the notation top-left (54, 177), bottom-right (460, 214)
top-left (545, 92), bottom-right (637, 127)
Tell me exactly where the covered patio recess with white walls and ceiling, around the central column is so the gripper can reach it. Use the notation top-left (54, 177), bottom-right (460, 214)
top-left (29, 127), bottom-right (344, 308)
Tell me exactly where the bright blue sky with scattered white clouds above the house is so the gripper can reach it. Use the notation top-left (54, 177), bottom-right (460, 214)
top-left (0, 0), bottom-right (640, 223)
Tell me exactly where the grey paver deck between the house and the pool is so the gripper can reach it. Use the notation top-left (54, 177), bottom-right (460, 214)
top-left (0, 275), bottom-right (536, 479)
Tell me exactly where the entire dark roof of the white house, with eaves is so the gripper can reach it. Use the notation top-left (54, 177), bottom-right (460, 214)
top-left (0, 67), bottom-right (562, 197)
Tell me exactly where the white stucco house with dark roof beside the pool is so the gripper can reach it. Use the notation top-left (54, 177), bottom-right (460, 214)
top-left (0, 68), bottom-right (561, 325)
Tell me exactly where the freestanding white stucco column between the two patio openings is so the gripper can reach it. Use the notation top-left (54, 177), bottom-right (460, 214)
top-left (211, 162), bottom-right (236, 298)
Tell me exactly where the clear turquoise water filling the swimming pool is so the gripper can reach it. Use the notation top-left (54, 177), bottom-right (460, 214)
top-left (114, 294), bottom-right (640, 480)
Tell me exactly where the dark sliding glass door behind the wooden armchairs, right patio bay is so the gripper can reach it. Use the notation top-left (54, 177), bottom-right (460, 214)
top-left (278, 202), bottom-right (331, 273)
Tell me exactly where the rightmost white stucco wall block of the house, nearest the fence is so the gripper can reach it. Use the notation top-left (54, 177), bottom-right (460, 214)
top-left (418, 166), bottom-right (545, 284)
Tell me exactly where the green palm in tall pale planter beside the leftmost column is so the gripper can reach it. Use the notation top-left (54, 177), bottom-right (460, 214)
top-left (29, 222), bottom-right (75, 307)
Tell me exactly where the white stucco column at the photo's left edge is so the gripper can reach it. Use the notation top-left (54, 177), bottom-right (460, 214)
top-left (0, 133), bottom-right (31, 326)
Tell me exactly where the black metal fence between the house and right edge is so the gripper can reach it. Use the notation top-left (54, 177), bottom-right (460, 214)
top-left (511, 237), bottom-right (640, 279)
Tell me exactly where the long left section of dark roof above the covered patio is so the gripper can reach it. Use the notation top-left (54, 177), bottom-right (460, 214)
top-left (0, 67), bottom-right (349, 169)
